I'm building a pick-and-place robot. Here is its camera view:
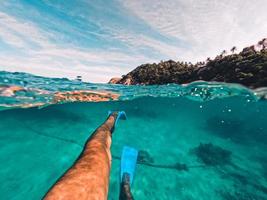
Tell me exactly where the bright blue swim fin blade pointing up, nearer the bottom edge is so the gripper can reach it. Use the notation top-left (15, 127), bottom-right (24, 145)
top-left (120, 146), bottom-right (138, 185)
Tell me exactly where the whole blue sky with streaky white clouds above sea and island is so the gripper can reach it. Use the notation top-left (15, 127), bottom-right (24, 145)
top-left (0, 0), bottom-right (267, 82)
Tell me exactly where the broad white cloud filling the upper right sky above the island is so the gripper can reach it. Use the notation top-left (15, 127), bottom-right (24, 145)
top-left (121, 0), bottom-right (267, 61)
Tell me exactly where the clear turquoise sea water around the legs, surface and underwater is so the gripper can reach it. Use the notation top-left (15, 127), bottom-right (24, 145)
top-left (0, 72), bottom-right (267, 200)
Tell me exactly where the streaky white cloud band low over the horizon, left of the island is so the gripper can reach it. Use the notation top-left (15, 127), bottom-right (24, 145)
top-left (0, 12), bottom-right (151, 82)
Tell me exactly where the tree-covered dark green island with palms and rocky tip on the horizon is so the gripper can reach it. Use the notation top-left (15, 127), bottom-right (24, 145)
top-left (109, 38), bottom-right (267, 88)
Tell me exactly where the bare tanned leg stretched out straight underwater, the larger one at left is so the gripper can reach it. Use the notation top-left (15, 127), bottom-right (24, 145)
top-left (44, 112), bottom-right (118, 200)
